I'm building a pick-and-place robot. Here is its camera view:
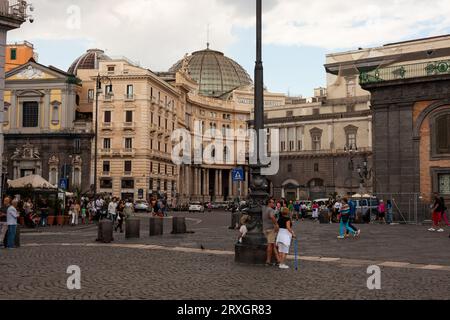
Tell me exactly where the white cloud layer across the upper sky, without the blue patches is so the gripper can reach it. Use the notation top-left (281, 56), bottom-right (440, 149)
top-left (9, 0), bottom-right (450, 70)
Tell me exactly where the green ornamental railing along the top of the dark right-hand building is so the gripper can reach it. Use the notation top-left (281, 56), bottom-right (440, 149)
top-left (359, 60), bottom-right (450, 84)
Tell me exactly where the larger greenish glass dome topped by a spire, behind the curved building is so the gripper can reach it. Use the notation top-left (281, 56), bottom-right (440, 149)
top-left (169, 48), bottom-right (253, 98)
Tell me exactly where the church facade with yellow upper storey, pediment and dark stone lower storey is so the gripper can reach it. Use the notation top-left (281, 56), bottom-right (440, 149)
top-left (3, 61), bottom-right (93, 192)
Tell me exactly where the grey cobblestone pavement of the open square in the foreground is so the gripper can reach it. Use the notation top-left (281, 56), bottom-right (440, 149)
top-left (0, 212), bottom-right (450, 300)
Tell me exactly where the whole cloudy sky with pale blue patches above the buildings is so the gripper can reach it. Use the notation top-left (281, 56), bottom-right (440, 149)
top-left (8, 0), bottom-right (450, 96)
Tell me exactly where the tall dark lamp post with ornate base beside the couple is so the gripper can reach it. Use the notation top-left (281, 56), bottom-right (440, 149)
top-left (235, 0), bottom-right (269, 264)
